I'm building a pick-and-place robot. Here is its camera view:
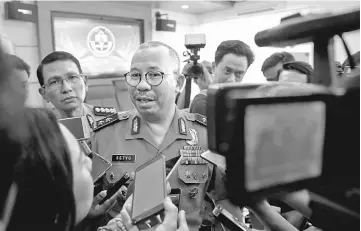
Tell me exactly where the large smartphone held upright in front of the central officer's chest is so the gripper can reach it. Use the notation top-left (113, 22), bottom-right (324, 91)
top-left (131, 155), bottom-right (167, 227)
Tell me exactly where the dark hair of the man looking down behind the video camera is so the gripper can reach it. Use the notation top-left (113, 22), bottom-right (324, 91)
top-left (214, 40), bottom-right (255, 67)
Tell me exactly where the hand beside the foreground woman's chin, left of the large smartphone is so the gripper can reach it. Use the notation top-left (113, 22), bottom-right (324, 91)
top-left (87, 188), bottom-right (125, 219)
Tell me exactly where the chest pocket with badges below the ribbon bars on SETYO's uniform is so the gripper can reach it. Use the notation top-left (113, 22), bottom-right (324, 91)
top-left (178, 164), bottom-right (210, 213)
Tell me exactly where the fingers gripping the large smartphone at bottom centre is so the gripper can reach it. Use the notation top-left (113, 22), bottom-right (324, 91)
top-left (121, 197), bottom-right (189, 231)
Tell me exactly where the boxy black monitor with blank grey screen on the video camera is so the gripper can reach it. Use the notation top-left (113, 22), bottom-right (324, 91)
top-left (207, 83), bottom-right (336, 206)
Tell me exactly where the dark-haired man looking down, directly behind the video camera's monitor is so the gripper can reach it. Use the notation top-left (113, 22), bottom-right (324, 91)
top-left (189, 40), bottom-right (255, 116)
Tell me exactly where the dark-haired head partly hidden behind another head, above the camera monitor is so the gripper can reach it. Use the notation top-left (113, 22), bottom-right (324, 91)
top-left (261, 51), bottom-right (296, 81)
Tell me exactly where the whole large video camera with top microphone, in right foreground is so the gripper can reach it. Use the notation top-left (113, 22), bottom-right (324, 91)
top-left (202, 11), bottom-right (360, 231)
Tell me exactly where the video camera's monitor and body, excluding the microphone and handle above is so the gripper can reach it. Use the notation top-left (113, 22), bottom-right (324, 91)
top-left (207, 83), bottom-right (360, 215)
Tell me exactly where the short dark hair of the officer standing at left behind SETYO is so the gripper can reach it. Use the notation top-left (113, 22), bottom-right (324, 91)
top-left (36, 51), bottom-right (83, 86)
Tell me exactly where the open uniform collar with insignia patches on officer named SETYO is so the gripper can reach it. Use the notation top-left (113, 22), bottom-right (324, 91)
top-left (125, 107), bottom-right (192, 152)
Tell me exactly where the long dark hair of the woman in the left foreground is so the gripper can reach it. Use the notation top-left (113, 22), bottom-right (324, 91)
top-left (7, 109), bottom-right (75, 231)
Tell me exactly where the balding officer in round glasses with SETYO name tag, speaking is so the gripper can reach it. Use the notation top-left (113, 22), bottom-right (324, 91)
top-left (92, 42), bottom-right (241, 230)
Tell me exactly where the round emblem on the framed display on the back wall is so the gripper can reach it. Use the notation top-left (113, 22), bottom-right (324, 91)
top-left (87, 26), bottom-right (115, 57)
